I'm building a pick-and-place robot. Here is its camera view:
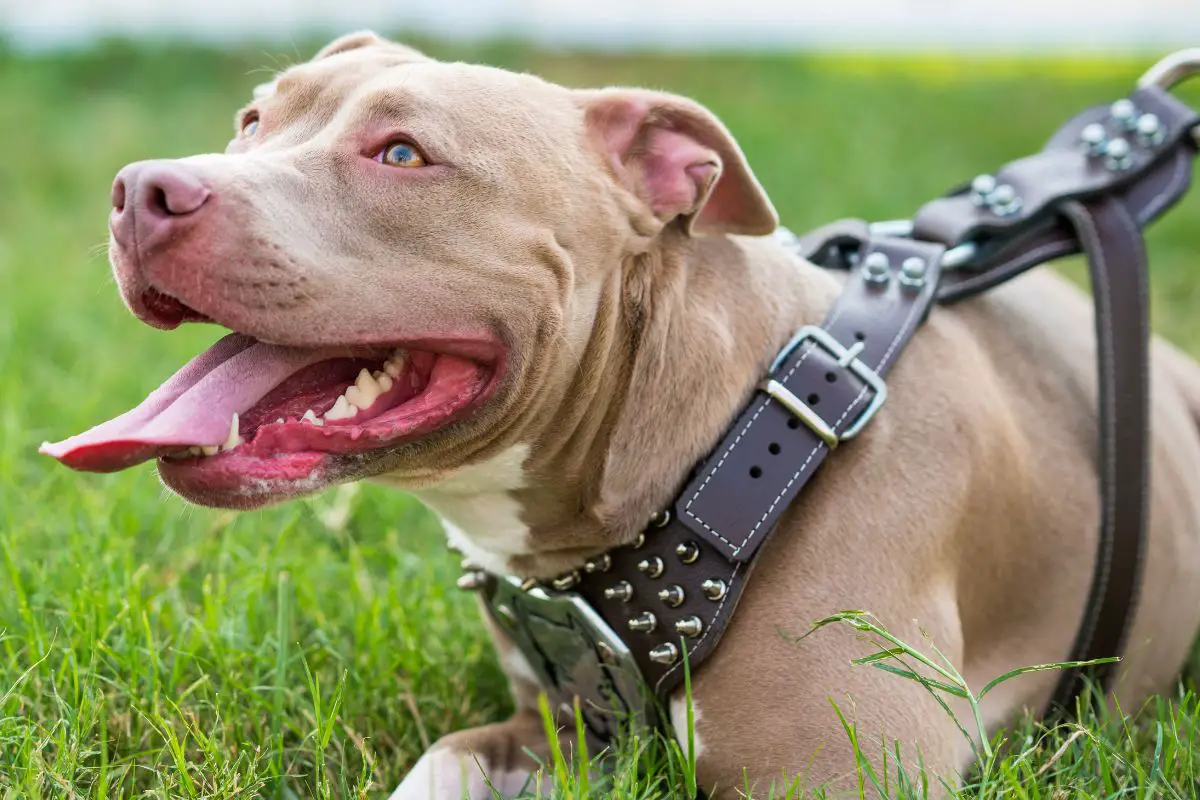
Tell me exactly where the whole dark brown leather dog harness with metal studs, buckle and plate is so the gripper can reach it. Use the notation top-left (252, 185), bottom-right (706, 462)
top-left (460, 50), bottom-right (1200, 741)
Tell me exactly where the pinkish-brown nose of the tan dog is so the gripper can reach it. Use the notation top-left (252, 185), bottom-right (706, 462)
top-left (112, 161), bottom-right (212, 247)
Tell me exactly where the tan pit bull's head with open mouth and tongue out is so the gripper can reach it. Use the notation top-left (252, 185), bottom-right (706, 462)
top-left (43, 34), bottom-right (776, 507)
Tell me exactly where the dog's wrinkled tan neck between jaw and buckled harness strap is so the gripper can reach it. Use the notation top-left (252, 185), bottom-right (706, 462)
top-left (408, 234), bottom-right (838, 577)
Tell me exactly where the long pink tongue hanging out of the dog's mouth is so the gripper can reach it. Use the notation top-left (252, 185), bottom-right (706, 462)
top-left (41, 333), bottom-right (330, 473)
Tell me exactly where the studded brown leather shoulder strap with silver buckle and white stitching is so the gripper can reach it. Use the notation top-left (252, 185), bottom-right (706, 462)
top-left (572, 239), bottom-right (944, 696)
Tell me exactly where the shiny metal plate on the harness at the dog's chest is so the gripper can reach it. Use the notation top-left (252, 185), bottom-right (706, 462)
top-left (480, 575), bottom-right (655, 746)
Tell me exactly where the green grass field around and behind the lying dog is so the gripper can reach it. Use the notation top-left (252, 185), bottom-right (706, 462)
top-left (0, 35), bottom-right (1200, 799)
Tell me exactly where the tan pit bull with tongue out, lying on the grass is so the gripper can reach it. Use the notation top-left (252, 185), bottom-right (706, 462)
top-left (44, 32), bottom-right (1200, 799)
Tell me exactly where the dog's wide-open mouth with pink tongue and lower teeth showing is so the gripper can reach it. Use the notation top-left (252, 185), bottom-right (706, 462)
top-left (41, 333), bottom-right (497, 506)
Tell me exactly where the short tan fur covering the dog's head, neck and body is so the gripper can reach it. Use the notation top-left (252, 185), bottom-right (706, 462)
top-left (117, 35), bottom-right (1200, 796)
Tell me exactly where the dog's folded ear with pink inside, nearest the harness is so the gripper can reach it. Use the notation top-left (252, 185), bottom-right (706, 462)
top-left (584, 89), bottom-right (779, 235)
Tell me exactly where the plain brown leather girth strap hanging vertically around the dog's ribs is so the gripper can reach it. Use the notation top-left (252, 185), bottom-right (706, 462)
top-left (1051, 198), bottom-right (1150, 710)
